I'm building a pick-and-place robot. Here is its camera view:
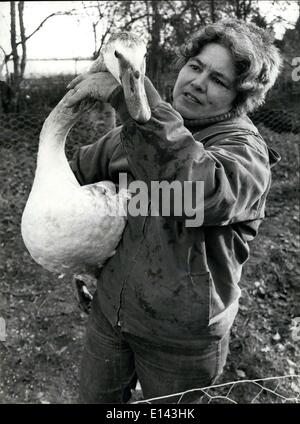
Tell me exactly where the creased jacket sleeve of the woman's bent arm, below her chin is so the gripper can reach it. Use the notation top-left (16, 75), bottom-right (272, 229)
top-left (113, 81), bottom-right (270, 225)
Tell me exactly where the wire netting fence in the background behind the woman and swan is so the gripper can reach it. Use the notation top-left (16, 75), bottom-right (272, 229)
top-left (0, 105), bottom-right (300, 177)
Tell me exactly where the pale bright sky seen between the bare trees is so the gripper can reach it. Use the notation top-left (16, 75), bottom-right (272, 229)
top-left (0, 0), bottom-right (299, 58)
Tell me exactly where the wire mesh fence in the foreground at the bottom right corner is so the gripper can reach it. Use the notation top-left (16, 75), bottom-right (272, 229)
top-left (131, 375), bottom-right (300, 404)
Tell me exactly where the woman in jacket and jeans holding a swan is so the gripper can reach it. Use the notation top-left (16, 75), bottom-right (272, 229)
top-left (65, 20), bottom-right (280, 403)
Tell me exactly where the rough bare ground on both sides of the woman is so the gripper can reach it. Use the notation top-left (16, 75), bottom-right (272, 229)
top-left (0, 118), bottom-right (300, 403)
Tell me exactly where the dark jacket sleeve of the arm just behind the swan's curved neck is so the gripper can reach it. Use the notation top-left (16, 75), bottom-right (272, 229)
top-left (69, 127), bottom-right (121, 185)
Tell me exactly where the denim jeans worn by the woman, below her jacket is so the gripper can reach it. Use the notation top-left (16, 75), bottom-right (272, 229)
top-left (79, 296), bottom-right (229, 404)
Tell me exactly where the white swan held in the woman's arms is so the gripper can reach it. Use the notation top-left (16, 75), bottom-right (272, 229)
top-left (21, 32), bottom-right (151, 282)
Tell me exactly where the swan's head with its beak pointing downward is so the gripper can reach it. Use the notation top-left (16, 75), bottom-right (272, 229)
top-left (102, 32), bottom-right (151, 123)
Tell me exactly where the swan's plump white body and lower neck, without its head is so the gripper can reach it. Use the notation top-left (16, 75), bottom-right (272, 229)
top-left (21, 101), bottom-right (128, 274)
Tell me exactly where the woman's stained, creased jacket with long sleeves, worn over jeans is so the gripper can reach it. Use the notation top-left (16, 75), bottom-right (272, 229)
top-left (71, 83), bottom-right (278, 343)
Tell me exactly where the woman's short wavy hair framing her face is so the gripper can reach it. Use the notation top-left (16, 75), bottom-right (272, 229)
top-left (176, 19), bottom-right (281, 115)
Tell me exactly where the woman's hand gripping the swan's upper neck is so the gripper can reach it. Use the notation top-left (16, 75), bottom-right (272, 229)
top-left (65, 72), bottom-right (119, 107)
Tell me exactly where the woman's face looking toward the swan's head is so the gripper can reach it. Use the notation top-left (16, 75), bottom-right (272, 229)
top-left (173, 43), bottom-right (236, 119)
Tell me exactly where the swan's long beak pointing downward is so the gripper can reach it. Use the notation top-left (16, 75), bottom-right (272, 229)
top-left (115, 51), bottom-right (151, 124)
